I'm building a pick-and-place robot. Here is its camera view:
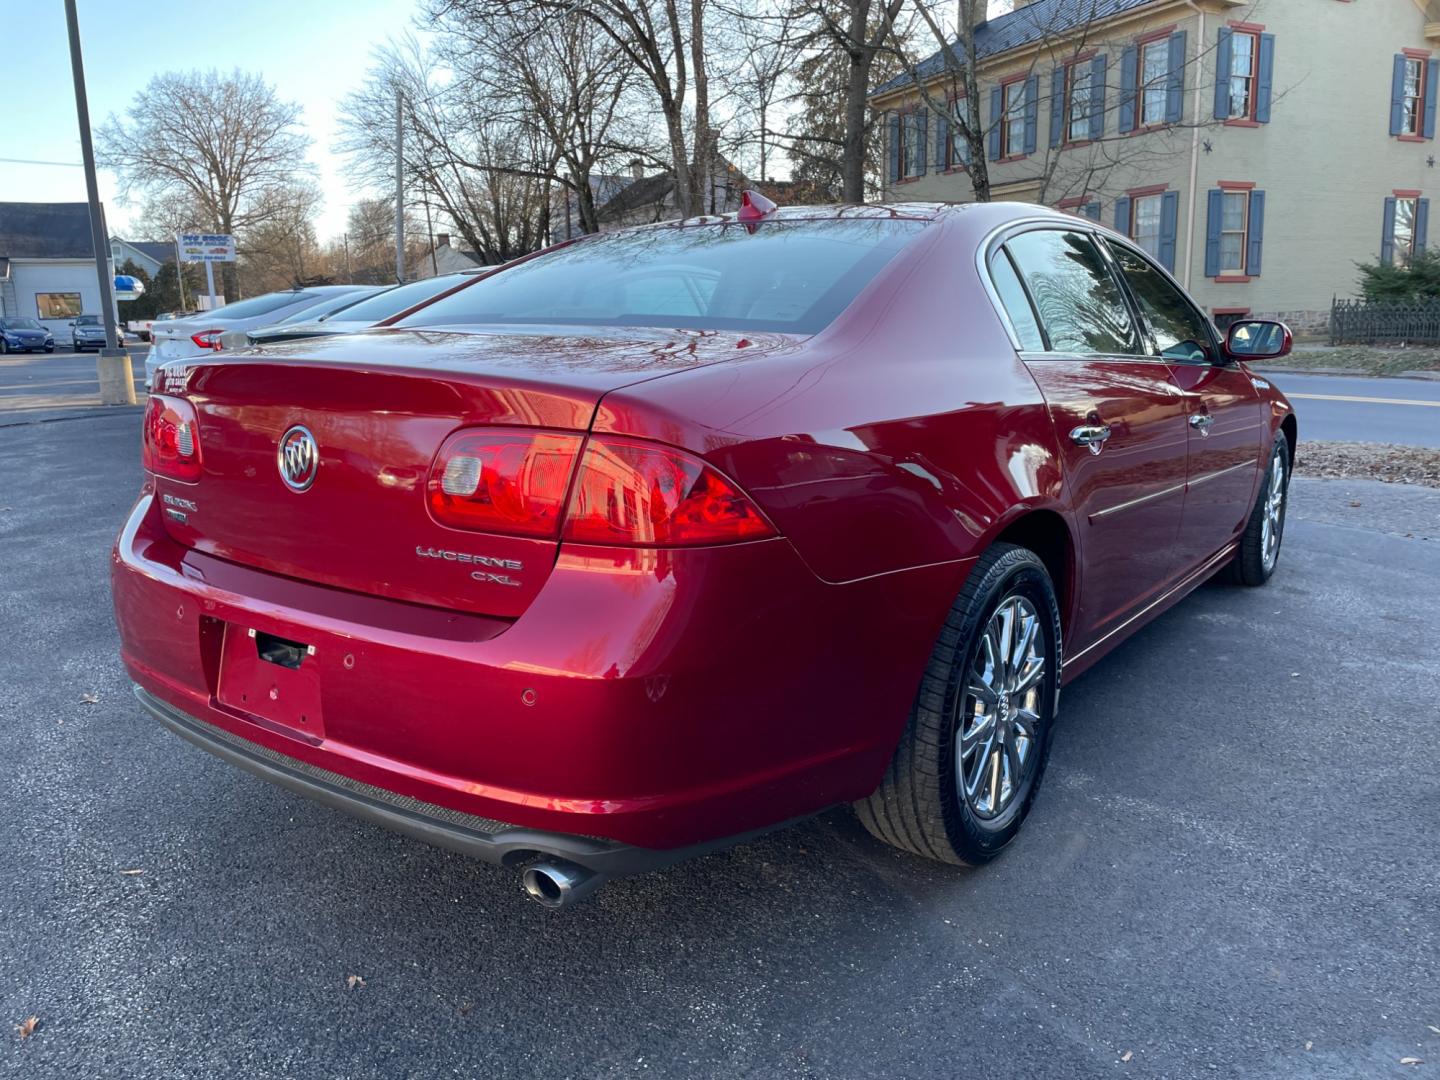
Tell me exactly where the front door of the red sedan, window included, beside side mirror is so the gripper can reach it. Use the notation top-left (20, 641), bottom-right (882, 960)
top-left (1107, 240), bottom-right (1266, 570)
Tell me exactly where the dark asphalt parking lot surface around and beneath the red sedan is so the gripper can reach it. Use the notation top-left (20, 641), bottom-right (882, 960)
top-left (0, 410), bottom-right (1440, 1080)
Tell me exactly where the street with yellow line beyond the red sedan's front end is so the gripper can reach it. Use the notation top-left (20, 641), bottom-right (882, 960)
top-left (1264, 372), bottom-right (1440, 448)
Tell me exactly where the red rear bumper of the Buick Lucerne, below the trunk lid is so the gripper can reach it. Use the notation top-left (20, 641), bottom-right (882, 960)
top-left (111, 494), bottom-right (969, 873)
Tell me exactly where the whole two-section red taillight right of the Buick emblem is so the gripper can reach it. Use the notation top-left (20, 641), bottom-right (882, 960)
top-left (426, 428), bottom-right (776, 547)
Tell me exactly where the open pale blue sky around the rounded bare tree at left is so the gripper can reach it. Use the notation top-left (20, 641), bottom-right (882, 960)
top-left (0, 0), bottom-right (416, 239)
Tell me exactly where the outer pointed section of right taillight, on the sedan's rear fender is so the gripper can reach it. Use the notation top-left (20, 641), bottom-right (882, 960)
top-left (564, 438), bottom-right (776, 547)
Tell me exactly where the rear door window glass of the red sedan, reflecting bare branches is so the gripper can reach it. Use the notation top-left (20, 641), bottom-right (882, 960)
top-left (1005, 230), bottom-right (1135, 353)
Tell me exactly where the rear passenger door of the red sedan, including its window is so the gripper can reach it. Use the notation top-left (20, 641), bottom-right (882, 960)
top-left (989, 228), bottom-right (1187, 651)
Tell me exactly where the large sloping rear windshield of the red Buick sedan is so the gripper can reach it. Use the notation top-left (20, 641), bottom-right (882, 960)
top-left (397, 217), bottom-right (926, 334)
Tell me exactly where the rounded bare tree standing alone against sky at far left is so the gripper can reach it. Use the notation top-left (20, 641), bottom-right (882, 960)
top-left (96, 71), bottom-right (310, 298)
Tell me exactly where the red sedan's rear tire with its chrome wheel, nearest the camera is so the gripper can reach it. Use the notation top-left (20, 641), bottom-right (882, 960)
top-left (855, 543), bottom-right (1061, 865)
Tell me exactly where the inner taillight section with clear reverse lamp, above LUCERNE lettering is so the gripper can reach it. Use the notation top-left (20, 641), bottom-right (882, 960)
top-left (426, 428), bottom-right (583, 537)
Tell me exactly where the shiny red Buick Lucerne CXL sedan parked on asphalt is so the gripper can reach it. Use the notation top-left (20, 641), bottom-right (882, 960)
top-left (114, 199), bottom-right (1296, 906)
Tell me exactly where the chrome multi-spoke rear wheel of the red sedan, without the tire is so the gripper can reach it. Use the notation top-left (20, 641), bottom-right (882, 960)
top-left (955, 593), bottom-right (1045, 819)
